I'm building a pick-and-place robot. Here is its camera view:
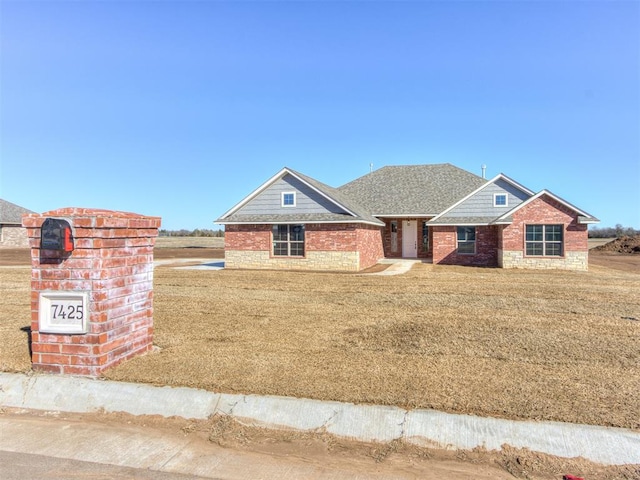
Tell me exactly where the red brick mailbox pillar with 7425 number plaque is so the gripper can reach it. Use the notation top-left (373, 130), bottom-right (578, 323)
top-left (22, 208), bottom-right (160, 376)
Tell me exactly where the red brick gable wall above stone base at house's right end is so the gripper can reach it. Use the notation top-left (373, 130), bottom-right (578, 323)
top-left (502, 195), bottom-right (589, 252)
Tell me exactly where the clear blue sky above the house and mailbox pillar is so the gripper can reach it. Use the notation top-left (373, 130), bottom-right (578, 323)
top-left (0, 0), bottom-right (640, 229)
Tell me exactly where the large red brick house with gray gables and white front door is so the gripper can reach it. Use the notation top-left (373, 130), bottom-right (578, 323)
top-left (216, 164), bottom-right (598, 271)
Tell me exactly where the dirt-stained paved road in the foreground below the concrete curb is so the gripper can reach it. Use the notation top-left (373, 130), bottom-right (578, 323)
top-left (0, 410), bottom-right (512, 480)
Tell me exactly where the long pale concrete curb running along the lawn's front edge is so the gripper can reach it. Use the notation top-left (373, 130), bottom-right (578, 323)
top-left (0, 372), bottom-right (640, 465)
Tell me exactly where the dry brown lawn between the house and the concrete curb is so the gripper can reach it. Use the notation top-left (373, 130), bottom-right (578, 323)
top-left (0, 253), bottom-right (640, 429)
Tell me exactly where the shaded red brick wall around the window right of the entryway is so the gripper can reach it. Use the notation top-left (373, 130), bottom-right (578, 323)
top-left (432, 225), bottom-right (500, 267)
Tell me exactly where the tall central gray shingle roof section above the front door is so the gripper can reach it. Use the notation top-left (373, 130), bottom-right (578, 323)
top-left (338, 163), bottom-right (486, 217)
